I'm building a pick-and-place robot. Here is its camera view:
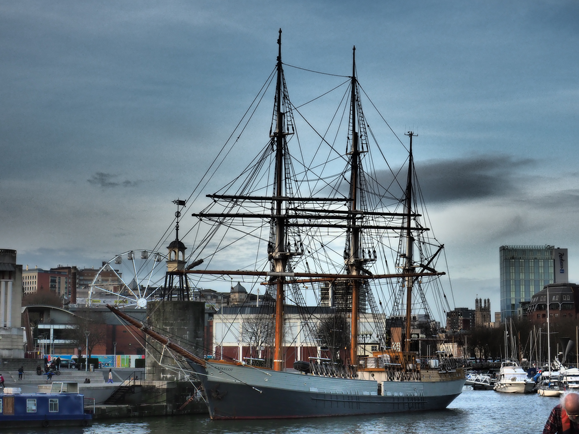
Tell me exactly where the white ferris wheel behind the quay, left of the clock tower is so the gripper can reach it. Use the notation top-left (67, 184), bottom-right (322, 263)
top-left (87, 250), bottom-right (167, 309)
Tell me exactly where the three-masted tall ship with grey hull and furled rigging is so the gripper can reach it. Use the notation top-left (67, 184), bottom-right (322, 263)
top-left (111, 30), bottom-right (465, 419)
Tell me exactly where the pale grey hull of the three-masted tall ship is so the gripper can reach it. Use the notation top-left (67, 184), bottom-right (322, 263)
top-left (191, 362), bottom-right (464, 420)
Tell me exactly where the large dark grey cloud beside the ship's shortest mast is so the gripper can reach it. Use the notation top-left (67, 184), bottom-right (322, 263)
top-left (377, 155), bottom-right (535, 203)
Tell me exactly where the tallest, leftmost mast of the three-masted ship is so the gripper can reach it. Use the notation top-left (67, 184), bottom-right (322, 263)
top-left (273, 29), bottom-right (287, 371)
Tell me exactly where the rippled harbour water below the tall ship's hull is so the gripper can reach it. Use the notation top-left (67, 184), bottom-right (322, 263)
top-left (1, 390), bottom-right (559, 434)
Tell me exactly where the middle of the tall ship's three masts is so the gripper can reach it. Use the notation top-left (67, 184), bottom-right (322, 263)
top-left (348, 47), bottom-right (360, 366)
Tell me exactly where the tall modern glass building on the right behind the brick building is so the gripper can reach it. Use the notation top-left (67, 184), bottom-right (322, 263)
top-left (499, 245), bottom-right (568, 321)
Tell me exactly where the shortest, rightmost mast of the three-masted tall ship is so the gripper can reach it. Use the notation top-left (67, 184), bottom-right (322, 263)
top-left (404, 131), bottom-right (416, 351)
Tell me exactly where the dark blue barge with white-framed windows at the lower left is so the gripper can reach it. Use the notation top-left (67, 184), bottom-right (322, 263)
top-left (0, 383), bottom-right (92, 430)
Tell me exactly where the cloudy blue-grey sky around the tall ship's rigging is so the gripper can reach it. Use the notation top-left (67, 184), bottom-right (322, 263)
top-left (0, 0), bottom-right (579, 318)
